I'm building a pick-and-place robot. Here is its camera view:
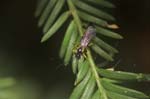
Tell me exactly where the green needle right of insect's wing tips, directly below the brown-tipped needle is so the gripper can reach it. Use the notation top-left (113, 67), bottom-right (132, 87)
top-left (95, 26), bottom-right (123, 39)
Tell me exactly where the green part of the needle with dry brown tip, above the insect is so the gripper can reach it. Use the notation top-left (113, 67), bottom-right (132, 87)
top-left (78, 10), bottom-right (108, 27)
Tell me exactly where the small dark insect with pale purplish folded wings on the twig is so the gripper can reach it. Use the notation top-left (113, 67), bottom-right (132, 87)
top-left (75, 26), bottom-right (96, 59)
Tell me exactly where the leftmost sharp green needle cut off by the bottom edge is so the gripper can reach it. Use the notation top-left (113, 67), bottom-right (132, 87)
top-left (69, 71), bottom-right (91, 99)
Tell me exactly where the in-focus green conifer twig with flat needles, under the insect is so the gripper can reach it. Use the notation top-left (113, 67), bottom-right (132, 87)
top-left (35, 0), bottom-right (150, 99)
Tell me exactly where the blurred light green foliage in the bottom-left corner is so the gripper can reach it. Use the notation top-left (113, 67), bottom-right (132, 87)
top-left (0, 77), bottom-right (40, 99)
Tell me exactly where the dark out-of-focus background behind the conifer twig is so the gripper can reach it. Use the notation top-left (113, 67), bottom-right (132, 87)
top-left (0, 0), bottom-right (150, 99)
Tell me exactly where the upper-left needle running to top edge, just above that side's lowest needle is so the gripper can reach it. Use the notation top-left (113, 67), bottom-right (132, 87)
top-left (43, 0), bottom-right (66, 33)
